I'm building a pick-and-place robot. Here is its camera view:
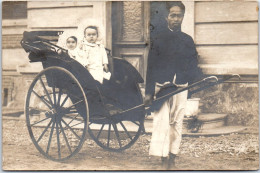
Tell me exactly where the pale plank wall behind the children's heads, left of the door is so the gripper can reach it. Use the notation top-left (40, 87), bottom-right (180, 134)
top-left (27, 1), bottom-right (111, 48)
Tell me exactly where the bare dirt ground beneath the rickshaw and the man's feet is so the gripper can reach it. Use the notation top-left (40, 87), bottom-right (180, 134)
top-left (2, 118), bottom-right (259, 170)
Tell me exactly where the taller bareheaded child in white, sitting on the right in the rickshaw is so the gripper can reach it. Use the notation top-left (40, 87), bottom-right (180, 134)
top-left (79, 26), bottom-right (111, 84)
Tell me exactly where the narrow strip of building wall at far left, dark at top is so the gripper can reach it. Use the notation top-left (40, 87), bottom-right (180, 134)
top-left (2, 2), bottom-right (28, 108)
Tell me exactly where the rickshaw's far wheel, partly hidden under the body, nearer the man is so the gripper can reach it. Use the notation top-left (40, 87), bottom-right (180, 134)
top-left (88, 85), bottom-right (145, 152)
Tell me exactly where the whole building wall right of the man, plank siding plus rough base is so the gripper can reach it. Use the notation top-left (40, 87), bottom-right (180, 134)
top-left (194, 1), bottom-right (259, 126)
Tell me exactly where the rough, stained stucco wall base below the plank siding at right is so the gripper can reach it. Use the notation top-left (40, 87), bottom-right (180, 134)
top-left (193, 83), bottom-right (259, 126)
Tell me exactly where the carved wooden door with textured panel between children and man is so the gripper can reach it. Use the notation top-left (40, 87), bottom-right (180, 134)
top-left (112, 1), bottom-right (150, 82)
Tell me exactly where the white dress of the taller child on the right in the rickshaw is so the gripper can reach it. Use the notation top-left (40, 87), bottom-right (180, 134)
top-left (80, 40), bottom-right (108, 84)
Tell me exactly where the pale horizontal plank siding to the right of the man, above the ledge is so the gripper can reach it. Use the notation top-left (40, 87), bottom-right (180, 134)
top-left (195, 1), bottom-right (258, 75)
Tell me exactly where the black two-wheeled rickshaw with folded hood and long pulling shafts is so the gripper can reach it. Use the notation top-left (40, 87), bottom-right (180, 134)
top-left (21, 31), bottom-right (240, 161)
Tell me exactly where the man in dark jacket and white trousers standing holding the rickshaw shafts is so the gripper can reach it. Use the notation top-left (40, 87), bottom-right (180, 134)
top-left (145, 1), bottom-right (202, 169)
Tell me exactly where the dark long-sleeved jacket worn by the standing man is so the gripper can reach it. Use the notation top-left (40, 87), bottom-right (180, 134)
top-left (145, 28), bottom-right (201, 95)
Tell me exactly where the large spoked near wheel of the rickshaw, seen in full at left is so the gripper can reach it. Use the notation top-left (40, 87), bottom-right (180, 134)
top-left (25, 66), bottom-right (89, 161)
